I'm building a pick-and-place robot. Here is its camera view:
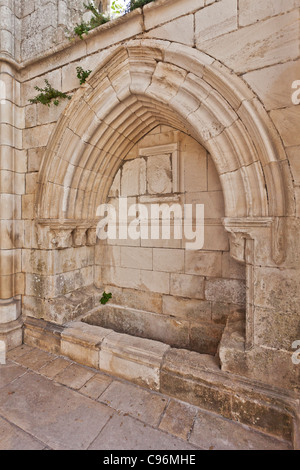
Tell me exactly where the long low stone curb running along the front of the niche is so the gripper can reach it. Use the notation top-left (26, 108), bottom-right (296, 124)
top-left (24, 318), bottom-right (299, 448)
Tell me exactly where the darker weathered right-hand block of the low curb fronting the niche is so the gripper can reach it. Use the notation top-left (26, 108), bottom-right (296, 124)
top-left (160, 349), bottom-right (297, 440)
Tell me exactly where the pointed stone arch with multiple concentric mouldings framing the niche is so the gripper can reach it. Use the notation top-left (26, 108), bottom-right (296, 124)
top-left (36, 40), bottom-right (286, 261)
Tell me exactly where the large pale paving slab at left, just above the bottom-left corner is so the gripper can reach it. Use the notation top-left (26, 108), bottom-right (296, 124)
top-left (0, 372), bottom-right (113, 450)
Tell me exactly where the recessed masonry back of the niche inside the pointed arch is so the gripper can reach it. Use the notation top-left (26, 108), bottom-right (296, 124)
top-left (92, 126), bottom-right (245, 355)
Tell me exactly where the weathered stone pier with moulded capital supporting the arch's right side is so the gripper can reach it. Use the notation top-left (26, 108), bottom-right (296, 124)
top-left (220, 217), bottom-right (300, 392)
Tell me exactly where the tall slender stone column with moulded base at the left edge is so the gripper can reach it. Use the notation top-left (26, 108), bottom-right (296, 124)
top-left (0, 0), bottom-right (25, 349)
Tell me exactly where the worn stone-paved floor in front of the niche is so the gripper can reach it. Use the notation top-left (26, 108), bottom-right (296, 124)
top-left (0, 345), bottom-right (291, 451)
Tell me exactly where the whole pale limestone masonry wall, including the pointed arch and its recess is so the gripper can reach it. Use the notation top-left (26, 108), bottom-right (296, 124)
top-left (0, 0), bottom-right (300, 391)
